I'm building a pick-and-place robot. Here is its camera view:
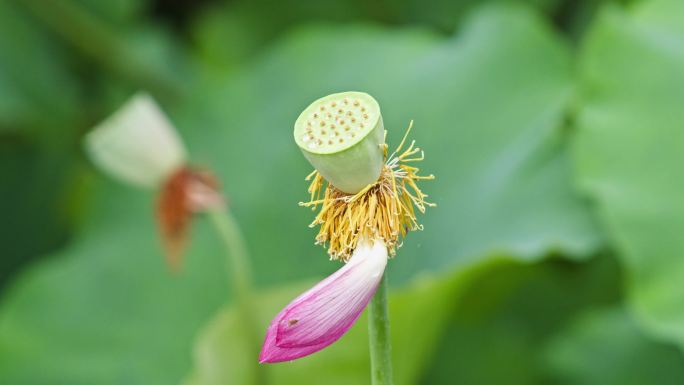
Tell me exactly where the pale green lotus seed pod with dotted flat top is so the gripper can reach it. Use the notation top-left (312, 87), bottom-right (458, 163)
top-left (294, 92), bottom-right (385, 194)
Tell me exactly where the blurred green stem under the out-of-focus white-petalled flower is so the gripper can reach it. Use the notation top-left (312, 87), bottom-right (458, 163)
top-left (208, 209), bottom-right (265, 385)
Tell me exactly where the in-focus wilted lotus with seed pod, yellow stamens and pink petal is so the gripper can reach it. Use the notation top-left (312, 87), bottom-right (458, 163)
top-left (260, 92), bottom-right (434, 362)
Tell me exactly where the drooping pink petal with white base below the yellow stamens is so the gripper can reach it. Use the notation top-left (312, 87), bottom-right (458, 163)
top-left (259, 241), bottom-right (387, 363)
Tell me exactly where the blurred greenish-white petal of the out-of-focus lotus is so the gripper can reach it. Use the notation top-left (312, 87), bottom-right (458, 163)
top-left (85, 93), bottom-right (187, 187)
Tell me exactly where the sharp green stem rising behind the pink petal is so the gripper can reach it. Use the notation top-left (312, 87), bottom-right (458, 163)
top-left (368, 273), bottom-right (392, 385)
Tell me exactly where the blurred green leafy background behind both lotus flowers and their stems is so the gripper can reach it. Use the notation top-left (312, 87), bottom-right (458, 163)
top-left (0, 0), bottom-right (684, 385)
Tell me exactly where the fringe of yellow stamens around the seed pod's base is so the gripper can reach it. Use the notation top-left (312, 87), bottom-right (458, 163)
top-left (299, 121), bottom-right (435, 261)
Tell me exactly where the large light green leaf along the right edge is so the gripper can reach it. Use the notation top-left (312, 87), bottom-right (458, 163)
top-left (575, 0), bottom-right (684, 344)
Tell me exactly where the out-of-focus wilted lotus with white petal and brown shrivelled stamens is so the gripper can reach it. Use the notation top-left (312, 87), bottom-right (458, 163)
top-left (85, 93), bottom-right (221, 270)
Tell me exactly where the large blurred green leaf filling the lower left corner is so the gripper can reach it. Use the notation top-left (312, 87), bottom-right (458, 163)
top-left (0, 184), bottom-right (228, 385)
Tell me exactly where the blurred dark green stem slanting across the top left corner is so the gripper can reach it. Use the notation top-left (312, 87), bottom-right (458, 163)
top-left (17, 0), bottom-right (181, 98)
